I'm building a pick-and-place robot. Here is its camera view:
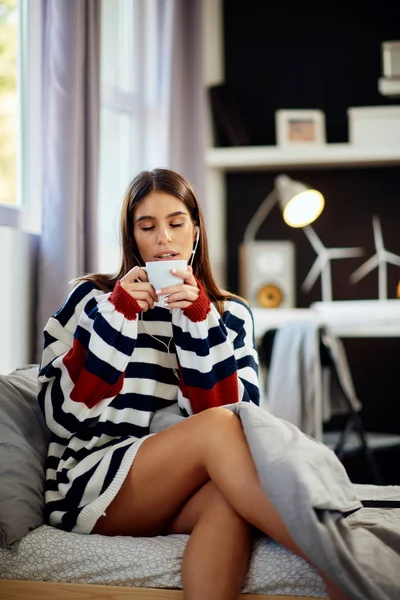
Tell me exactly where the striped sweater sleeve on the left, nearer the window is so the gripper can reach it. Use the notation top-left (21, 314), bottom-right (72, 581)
top-left (39, 281), bottom-right (140, 438)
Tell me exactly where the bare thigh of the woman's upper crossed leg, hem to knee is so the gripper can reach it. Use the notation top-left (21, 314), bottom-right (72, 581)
top-left (93, 408), bottom-right (237, 536)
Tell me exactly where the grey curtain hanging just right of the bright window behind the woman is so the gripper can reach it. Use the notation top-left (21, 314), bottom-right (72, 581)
top-left (170, 0), bottom-right (206, 203)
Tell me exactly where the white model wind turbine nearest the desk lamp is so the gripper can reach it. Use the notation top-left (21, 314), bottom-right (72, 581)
top-left (301, 226), bottom-right (363, 302)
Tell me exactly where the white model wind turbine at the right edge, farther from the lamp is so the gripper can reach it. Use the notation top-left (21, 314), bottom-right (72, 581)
top-left (349, 215), bottom-right (400, 300)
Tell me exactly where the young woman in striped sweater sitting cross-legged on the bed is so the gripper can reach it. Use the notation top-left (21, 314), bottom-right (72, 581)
top-left (39, 169), bottom-right (343, 600)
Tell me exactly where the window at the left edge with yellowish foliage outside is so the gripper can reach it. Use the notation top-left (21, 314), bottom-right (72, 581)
top-left (0, 0), bottom-right (41, 233)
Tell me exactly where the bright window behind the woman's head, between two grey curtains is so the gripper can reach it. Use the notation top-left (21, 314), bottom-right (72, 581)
top-left (99, 0), bottom-right (173, 272)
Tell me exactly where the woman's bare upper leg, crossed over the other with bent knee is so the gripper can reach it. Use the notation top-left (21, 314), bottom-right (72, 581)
top-left (94, 408), bottom-right (345, 600)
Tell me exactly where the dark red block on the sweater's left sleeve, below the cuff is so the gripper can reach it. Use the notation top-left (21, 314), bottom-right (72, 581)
top-left (63, 339), bottom-right (124, 408)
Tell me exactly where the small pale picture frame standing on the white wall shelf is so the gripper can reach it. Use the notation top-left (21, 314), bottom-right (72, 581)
top-left (275, 109), bottom-right (326, 147)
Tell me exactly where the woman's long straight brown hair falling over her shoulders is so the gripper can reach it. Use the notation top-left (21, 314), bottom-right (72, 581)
top-left (77, 169), bottom-right (235, 314)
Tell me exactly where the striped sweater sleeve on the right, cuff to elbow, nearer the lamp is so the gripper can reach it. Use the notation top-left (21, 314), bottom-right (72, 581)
top-left (171, 289), bottom-right (259, 414)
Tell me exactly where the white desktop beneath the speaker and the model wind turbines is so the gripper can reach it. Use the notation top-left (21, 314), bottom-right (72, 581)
top-left (252, 299), bottom-right (400, 339)
